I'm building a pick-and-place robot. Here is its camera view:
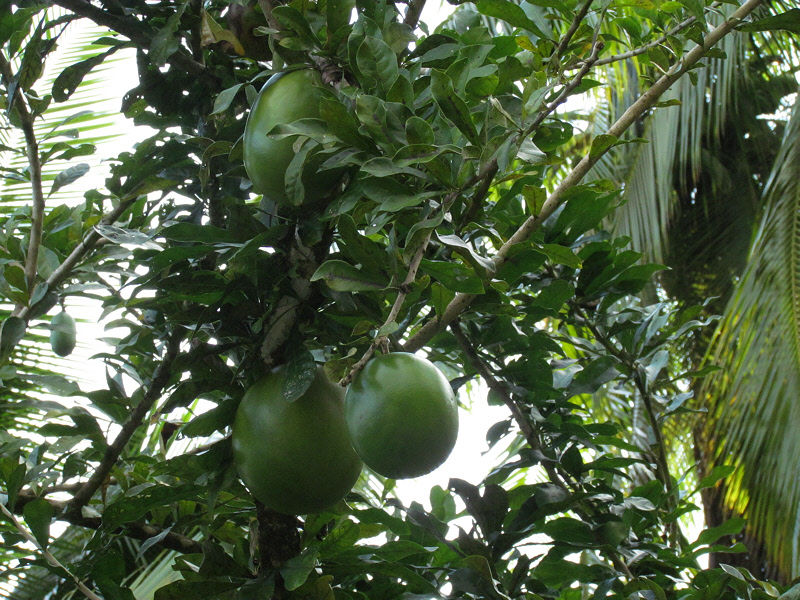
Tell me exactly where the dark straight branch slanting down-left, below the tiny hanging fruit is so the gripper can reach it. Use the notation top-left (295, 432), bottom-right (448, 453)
top-left (69, 330), bottom-right (183, 512)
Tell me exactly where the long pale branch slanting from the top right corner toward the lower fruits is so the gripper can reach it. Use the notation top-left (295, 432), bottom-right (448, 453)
top-left (404, 0), bottom-right (764, 352)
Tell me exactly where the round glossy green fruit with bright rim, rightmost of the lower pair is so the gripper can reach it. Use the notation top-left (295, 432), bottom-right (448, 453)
top-left (345, 352), bottom-right (458, 479)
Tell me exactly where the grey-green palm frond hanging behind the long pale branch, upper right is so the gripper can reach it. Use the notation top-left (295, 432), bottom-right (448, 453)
top-left (593, 7), bottom-right (746, 263)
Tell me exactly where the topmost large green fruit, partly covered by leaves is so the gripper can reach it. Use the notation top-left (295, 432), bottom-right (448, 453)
top-left (243, 69), bottom-right (343, 205)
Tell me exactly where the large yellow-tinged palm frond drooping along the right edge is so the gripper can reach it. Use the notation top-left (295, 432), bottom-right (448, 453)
top-left (702, 88), bottom-right (800, 575)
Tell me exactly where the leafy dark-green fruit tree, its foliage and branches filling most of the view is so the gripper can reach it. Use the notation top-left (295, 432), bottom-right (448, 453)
top-left (0, 0), bottom-right (796, 599)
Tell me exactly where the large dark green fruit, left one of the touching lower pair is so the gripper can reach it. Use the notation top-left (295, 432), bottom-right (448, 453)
top-left (232, 367), bottom-right (362, 515)
